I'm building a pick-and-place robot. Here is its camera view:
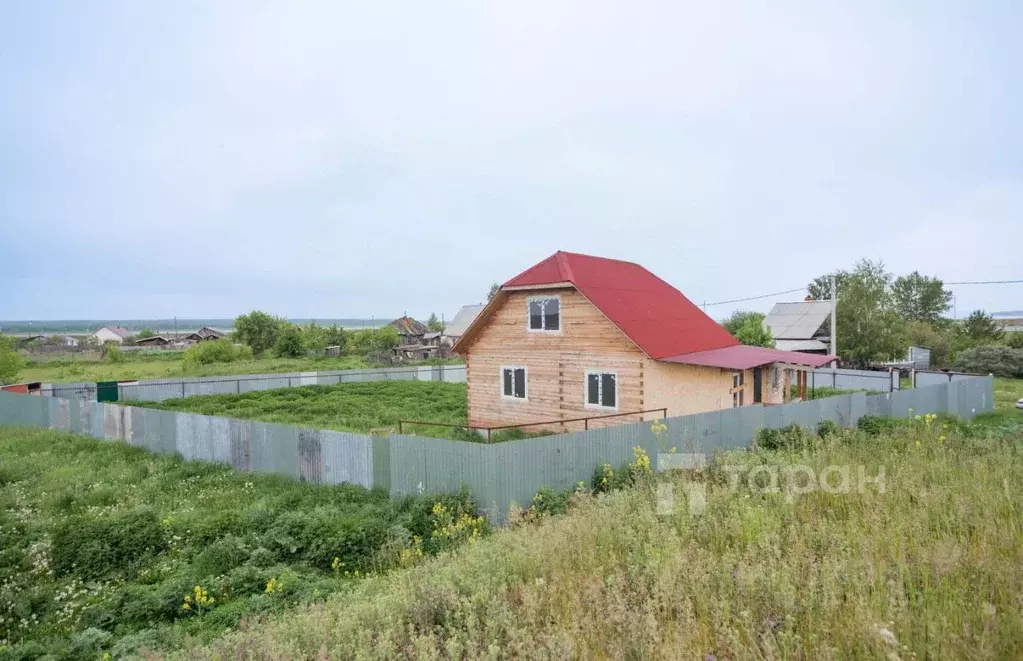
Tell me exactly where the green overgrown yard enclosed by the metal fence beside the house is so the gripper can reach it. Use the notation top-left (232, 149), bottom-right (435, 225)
top-left (133, 381), bottom-right (466, 438)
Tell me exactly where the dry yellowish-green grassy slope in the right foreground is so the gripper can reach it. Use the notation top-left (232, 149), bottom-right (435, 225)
top-left (170, 410), bottom-right (1023, 661)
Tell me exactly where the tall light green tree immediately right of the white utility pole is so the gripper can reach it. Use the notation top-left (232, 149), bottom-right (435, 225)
top-left (836, 259), bottom-right (909, 366)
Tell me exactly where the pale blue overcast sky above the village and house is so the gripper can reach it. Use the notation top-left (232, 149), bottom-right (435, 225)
top-left (0, 0), bottom-right (1023, 319)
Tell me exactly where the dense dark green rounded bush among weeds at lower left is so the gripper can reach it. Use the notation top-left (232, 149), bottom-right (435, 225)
top-left (53, 508), bottom-right (164, 579)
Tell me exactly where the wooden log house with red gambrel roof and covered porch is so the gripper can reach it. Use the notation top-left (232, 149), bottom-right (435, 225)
top-left (453, 252), bottom-right (835, 431)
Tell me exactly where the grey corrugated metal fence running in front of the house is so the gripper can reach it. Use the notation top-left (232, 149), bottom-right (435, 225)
top-left (0, 377), bottom-right (994, 520)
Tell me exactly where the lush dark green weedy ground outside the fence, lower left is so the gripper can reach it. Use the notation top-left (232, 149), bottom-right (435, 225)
top-left (0, 429), bottom-right (487, 661)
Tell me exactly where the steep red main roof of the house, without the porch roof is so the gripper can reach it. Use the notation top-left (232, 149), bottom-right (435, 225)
top-left (504, 252), bottom-right (740, 362)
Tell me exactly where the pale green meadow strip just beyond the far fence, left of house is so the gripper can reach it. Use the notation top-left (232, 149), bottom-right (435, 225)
top-left (18, 351), bottom-right (457, 384)
